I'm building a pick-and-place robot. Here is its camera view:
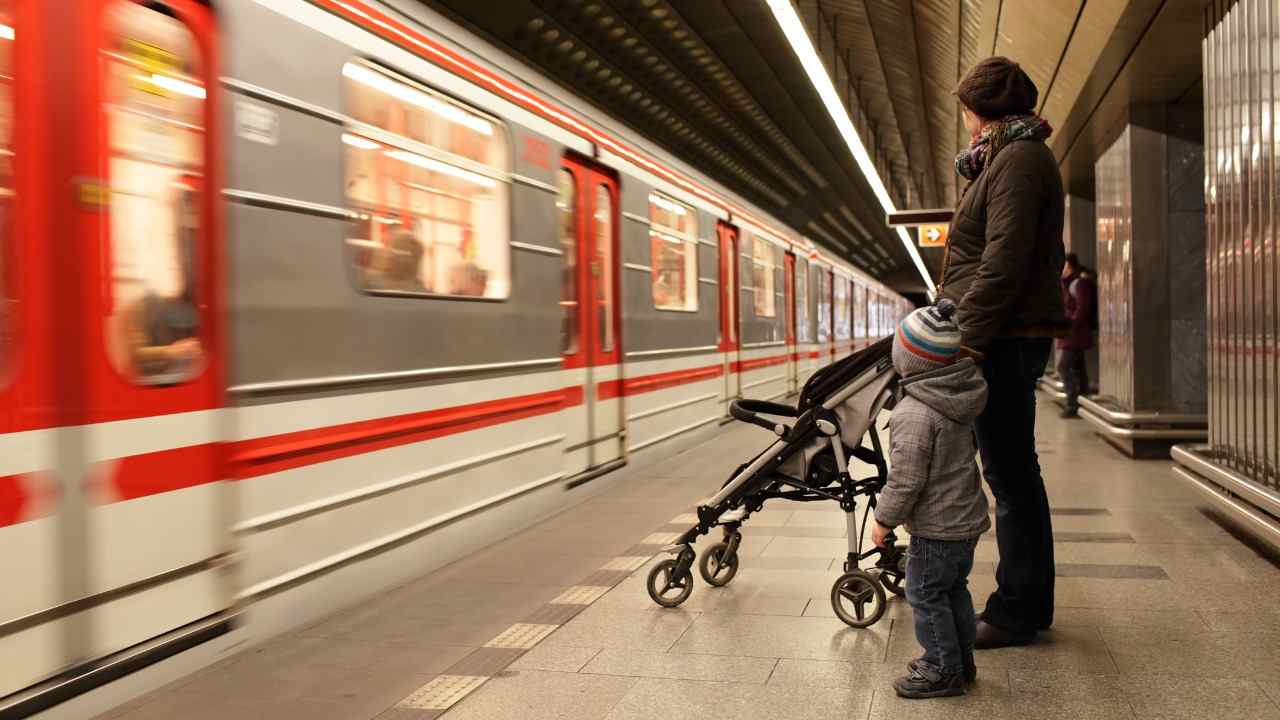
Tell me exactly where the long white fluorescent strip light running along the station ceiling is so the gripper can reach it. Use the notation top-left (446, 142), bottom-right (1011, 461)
top-left (767, 0), bottom-right (933, 291)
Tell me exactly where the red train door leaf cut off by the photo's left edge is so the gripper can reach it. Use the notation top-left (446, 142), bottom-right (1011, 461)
top-left (0, 0), bottom-right (65, 706)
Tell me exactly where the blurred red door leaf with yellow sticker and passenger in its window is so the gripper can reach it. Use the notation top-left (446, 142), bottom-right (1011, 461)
top-left (73, 0), bottom-right (233, 657)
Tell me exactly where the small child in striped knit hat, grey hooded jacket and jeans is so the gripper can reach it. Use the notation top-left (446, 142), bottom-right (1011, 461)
top-left (872, 300), bottom-right (991, 698)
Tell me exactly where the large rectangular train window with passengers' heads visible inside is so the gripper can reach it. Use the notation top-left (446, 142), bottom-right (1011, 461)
top-left (339, 56), bottom-right (516, 302)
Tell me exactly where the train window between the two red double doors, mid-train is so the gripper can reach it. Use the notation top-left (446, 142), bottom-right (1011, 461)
top-left (649, 193), bottom-right (698, 313)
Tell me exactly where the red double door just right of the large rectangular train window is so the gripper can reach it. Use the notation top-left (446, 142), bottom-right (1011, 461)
top-left (559, 155), bottom-right (625, 475)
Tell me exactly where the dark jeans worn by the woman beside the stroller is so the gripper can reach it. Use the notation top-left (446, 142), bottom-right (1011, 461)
top-left (975, 337), bottom-right (1055, 634)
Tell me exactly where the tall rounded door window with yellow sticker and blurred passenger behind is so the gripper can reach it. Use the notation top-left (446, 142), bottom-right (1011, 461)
top-left (101, 3), bottom-right (206, 384)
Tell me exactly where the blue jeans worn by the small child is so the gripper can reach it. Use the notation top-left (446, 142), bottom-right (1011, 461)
top-left (906, 536), bottom-right (978, 675)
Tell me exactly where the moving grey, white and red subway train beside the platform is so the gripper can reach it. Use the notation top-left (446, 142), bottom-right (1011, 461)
top-left (0, 0), bottom-right (908, 708)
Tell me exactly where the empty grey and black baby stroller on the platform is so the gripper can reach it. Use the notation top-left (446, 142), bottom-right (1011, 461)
top-left (648, 337), bottom-right (906, 628)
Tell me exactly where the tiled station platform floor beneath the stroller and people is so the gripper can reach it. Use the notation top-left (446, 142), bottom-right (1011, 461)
top-left (94, 394), bottom-right (1280, 720)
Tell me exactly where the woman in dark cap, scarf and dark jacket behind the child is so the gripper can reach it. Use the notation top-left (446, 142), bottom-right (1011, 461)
top-left (938, 58), bottom-right (1068, 650)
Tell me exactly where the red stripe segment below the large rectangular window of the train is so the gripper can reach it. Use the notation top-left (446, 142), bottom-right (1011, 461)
top-left (232, 388), bottom-right (570, 479)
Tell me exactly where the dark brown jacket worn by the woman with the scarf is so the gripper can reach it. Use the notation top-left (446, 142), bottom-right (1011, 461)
top-left (941, 141), bottom-right (1070, 351)
